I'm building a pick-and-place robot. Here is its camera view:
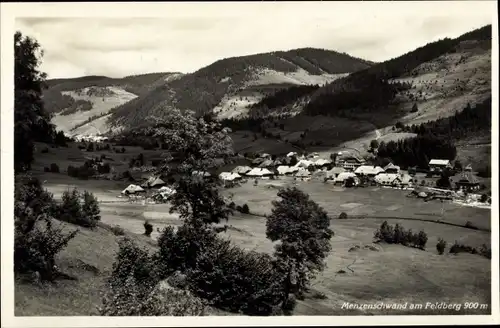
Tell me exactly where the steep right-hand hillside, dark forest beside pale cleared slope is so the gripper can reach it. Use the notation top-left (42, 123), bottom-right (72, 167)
top-left (304, 25), bottom-right (491, 126)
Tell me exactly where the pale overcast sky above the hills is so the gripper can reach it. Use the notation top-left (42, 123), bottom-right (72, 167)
top-left (15, 1), bottom-right (495, 78)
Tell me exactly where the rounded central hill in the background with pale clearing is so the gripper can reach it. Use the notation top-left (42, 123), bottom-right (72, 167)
top-left (108, 48), bottom-right (371, 126)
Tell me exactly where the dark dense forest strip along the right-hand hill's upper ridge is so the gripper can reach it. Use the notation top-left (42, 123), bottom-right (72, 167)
top-left (305, 25), bottom-right (492, 119)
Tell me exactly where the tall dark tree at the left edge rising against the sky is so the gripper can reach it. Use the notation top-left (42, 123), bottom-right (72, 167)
top-left (14, 32), bottom-right (55, 172)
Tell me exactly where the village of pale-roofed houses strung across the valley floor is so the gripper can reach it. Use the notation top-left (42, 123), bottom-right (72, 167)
top-left (112, 147), bottom-right (491, 207)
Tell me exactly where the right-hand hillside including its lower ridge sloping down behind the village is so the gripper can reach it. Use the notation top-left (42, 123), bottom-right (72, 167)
top-left (214, 25), bottom-right (491, 159)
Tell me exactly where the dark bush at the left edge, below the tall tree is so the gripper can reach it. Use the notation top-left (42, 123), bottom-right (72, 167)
top-left (14, 177), bottom-right (78, 280)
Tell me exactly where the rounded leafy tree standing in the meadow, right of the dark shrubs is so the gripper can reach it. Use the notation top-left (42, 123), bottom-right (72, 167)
top-left (266, 187), bottom-right (333, 304)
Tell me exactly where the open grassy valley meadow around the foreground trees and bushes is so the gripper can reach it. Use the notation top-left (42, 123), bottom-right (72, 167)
top-left (15, 143), bottom-right (491, 315)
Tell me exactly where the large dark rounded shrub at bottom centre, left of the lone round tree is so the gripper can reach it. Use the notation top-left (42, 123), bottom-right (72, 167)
top-left (187, 233), bottom-right (283, 315)
